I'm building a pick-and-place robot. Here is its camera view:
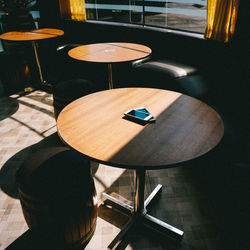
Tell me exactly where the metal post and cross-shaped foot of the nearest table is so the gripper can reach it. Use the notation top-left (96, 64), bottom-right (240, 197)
top-left (102, 169), bottom-right (184, 249)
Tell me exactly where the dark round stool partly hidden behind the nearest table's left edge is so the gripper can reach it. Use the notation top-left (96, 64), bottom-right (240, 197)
top-left (52, 78), bottom-right (93, 119)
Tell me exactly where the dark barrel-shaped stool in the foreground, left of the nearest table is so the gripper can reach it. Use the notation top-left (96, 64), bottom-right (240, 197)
top-left (16, 147), bottom-right (97, 249)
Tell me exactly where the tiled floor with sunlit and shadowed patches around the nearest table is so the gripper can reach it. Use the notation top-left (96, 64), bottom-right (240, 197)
top-left (0, 87), bottom-right (229, 250)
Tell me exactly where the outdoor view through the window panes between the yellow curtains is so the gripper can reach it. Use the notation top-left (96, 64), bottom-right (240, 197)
top-left (85, 0), bottom-right (207, 33)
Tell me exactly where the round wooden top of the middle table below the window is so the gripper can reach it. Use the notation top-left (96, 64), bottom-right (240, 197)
top-left (68, 43), bottom-right (152, 63)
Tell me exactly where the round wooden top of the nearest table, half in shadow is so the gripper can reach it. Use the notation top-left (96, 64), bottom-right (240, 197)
top-left (57, 88), bottom-right (224, 169)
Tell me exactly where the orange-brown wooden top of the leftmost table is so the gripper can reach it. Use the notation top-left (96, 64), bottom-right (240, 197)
top-left (0, 28), bottom-right (64, 41)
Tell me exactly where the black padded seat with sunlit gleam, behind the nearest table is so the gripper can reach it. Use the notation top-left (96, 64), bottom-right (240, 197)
top-left (121, 59), bottom-right (211, 102)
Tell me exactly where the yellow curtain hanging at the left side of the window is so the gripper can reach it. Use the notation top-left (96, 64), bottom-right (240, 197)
top-left (59, 0), bottom-right (86, 21)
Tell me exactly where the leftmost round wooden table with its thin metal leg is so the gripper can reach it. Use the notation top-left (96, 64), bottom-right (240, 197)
top-left (0, 28), bottom-right (64, 89)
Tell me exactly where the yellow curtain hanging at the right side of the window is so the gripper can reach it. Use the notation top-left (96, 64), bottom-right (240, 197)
top-left (205, 0), bottom-right (240, 42)
